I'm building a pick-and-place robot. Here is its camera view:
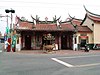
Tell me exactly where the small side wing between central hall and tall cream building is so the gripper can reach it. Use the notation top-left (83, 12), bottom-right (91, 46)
top-left (67, 16), bottom-right (92, 50)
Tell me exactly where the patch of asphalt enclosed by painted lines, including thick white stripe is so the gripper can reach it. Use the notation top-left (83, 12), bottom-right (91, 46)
top-left (51, 54), bottom-right (100, 68)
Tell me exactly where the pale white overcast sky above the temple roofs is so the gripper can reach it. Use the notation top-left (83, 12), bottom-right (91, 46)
top-left (0, 0), bottom-right (100, 34)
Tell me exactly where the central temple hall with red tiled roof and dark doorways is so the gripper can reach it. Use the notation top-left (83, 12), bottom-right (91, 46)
top-left (15, 17), bottom-right (75, 50)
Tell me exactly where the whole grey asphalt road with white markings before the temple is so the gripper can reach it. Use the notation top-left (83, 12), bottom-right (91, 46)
top-left (0, 52), bottom-right (100, 75)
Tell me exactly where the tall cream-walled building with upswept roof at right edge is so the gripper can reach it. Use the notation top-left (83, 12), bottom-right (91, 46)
top-left (81, 7), bottom-right (100, 49)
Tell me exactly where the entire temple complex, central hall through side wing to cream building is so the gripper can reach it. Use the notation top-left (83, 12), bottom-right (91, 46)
top-left (14, 8), bottom-right (100, 51)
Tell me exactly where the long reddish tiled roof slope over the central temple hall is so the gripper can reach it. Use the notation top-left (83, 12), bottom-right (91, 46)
top-left (16, 22), bottom-right (75, 31)
